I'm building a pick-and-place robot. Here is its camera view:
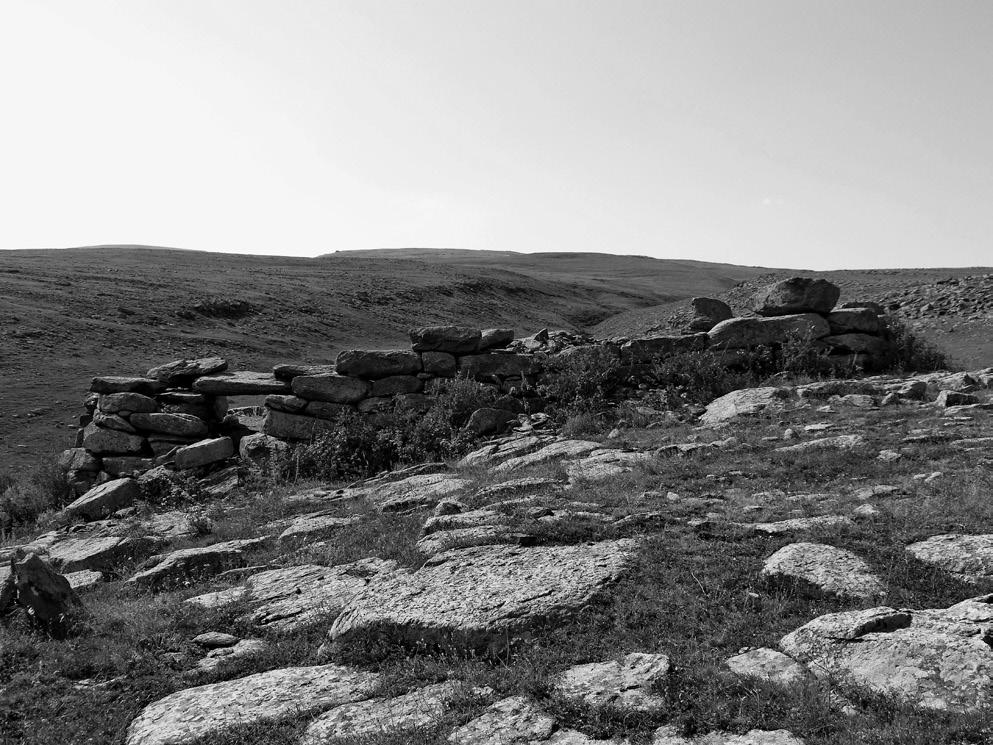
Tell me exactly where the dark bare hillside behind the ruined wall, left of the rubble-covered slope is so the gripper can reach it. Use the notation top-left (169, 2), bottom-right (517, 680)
top-left (0, 246), bottom-right (767, 471)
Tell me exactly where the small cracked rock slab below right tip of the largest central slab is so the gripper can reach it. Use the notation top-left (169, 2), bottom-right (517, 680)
top-left (555, 652), bottom-right (672, 713)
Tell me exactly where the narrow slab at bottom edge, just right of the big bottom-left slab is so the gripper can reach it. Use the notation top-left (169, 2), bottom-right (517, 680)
top-left (300, 681), bottom-right (471, 745)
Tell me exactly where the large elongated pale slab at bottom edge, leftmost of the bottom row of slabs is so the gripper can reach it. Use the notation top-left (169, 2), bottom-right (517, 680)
top-left (125, 665), bottom-right (379, 745)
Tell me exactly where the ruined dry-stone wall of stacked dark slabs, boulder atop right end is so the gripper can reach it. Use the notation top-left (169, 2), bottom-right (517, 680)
top-left (61, 278), bottom-right (888, 495)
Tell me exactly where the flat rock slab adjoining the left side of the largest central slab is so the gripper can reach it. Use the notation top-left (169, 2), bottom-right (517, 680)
top-left (186, 559), bottom-right (397, 632)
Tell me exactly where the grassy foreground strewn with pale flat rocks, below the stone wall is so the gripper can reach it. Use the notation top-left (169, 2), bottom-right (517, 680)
top-left (0, 358), bottom-right (993, 745)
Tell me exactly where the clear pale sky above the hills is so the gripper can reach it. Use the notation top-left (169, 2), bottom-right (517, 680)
top-left (0, 0), bottom-right (993, 269)
